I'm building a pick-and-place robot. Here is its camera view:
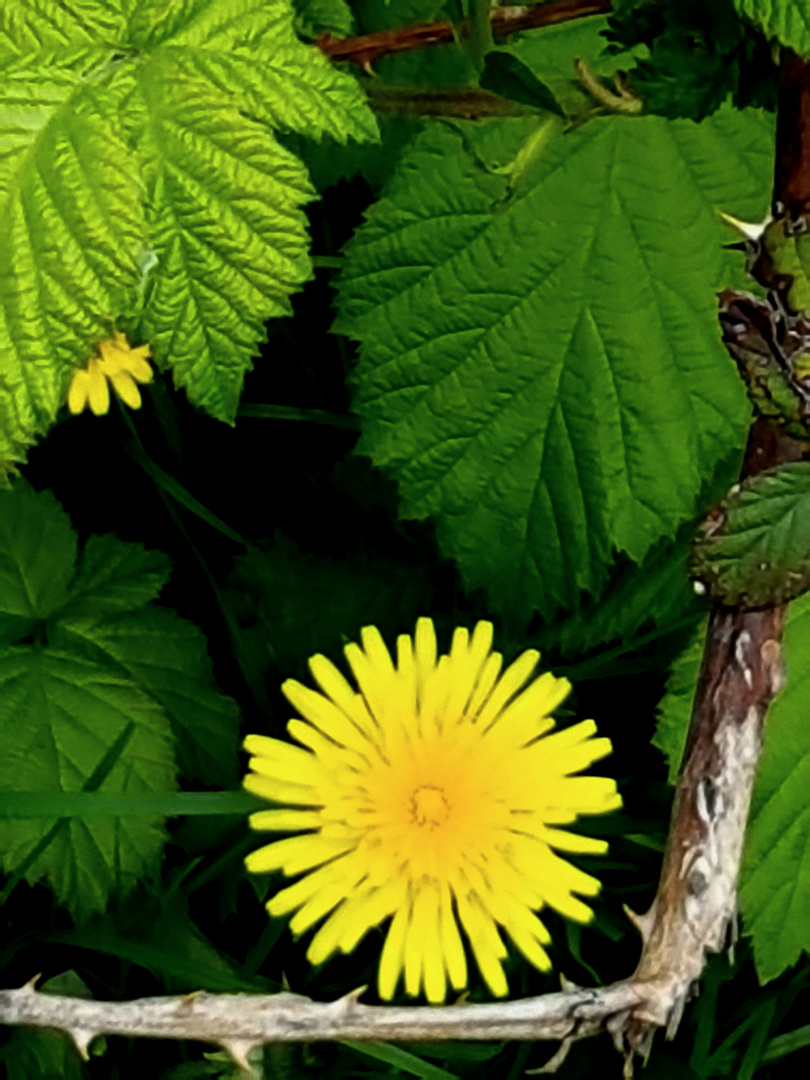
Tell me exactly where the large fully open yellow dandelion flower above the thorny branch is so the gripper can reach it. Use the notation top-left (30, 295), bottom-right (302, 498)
top-left (244, 619), bottom-right (621, 1003)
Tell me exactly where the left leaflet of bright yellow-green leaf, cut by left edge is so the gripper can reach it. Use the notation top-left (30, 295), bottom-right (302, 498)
top-left (0, 68), bottom-right (146, 467)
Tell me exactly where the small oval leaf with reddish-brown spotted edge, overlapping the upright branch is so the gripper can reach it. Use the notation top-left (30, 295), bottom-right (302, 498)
top-left (692, 461), bottom-right (810, 607)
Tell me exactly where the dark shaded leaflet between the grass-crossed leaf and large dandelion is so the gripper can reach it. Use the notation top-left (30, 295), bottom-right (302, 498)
top-left (54, 607), bottom-right (240, 786)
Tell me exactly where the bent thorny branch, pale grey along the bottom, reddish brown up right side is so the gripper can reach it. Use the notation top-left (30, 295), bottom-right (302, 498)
top-left (0, 23), bottom-right (810, 1076)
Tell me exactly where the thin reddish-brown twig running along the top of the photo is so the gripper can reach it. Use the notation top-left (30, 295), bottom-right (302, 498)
top-left (316, 0), bottom-right (611, 70)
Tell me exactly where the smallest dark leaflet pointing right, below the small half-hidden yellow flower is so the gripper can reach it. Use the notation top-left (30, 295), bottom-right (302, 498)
top-left (63, 535), bottom-right (172, 618)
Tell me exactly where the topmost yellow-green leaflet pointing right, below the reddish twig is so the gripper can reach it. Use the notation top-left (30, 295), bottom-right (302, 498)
top-left (129, 0), bottom-right (378, 141)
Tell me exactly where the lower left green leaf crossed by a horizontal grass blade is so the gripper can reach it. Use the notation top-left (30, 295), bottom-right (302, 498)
top-left (0, 646), bottom-right (175, 919)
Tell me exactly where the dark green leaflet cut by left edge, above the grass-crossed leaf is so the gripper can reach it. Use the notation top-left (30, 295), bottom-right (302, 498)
top-left (0, 481), bottom-right (76, 644)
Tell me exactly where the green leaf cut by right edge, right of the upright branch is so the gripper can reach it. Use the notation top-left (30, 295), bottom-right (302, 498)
top-left (740, 596), bottom-right (810, 982)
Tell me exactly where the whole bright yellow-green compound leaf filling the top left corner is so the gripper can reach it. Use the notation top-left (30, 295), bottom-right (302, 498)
top-left (0, 0), bottom-right (378, 481)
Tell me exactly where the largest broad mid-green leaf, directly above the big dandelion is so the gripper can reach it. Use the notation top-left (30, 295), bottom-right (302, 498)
top-left (335, 111), bottom-right (771, 618)
